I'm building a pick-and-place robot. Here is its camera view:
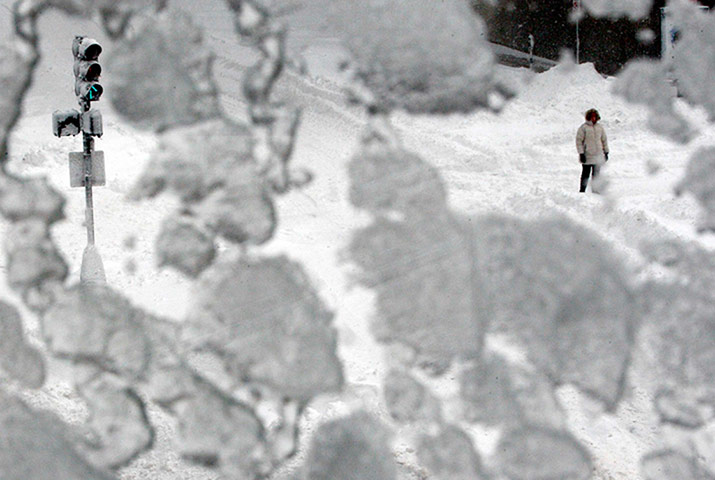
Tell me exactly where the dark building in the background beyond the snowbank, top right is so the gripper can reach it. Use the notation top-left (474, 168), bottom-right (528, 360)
top-left (472, 0), bottom-right (715, 75)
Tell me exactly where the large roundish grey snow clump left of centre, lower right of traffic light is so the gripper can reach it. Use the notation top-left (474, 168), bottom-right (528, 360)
top-left (183, 257), bottom-right (343, 404)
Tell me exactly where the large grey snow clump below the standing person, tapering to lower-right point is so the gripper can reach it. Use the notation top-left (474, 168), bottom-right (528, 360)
top-left (473, 216), bottom-right (637, 408)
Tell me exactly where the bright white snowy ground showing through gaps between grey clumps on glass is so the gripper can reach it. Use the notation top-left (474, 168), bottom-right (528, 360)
top-left (0, 1), bottom-right (715, 480)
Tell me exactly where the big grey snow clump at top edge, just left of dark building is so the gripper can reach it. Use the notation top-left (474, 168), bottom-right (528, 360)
top-left (331, 0), bottom-right (511, 113)
